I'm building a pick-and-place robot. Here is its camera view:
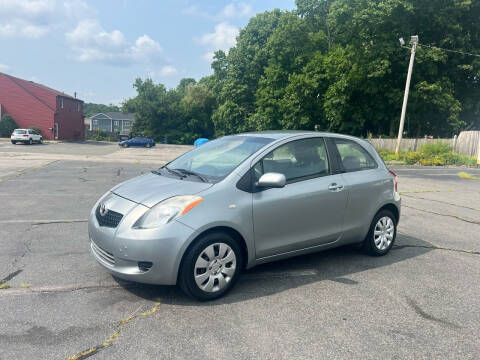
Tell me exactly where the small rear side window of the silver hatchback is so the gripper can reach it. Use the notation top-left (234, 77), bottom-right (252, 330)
top-left (334, 139), bottom-right (377, 172)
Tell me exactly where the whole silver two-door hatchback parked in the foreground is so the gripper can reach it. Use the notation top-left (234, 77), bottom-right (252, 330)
top-left (88, 131), bottom-right (400, 300)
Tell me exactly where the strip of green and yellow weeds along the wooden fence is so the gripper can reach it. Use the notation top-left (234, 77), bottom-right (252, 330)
top-left (378, 142), bottom-right (476, 166)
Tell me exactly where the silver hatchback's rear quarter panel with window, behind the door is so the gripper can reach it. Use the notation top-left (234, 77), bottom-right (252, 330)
top-left (330, 137), bottom-right (386, 240)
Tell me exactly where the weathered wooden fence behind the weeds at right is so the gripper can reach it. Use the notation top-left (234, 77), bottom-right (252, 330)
top-left (369, 131), bottom-right (480, 156)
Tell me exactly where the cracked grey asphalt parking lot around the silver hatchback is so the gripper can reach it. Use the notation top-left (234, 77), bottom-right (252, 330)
top-left (0, 142), bottom-right (480, 360)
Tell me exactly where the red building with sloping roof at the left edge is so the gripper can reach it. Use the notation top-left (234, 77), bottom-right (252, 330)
top-left (0, 73), bottom-right (85, 140)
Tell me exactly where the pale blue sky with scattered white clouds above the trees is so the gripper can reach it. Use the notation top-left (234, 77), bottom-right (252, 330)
top-left (0, 0), bottom-right (295, 104)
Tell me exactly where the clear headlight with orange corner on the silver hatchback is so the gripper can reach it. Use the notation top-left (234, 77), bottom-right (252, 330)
top-left (133, 195), bottom-right (203, 229)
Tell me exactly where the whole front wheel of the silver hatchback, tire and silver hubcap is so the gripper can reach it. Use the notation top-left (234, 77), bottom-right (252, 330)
top-left (179, 233), bottom-right (243, 301)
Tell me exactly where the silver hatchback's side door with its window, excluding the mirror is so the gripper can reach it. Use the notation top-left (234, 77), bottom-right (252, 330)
top-left (252, 137), bottom-right (347, 259)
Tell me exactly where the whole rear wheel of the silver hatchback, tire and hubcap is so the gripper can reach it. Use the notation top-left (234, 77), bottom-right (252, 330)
top-left (363, 210), bottom-right (397, 256)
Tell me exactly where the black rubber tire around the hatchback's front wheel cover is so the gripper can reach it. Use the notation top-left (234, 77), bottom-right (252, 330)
top-left (178, 232), bottom-right (243, 301)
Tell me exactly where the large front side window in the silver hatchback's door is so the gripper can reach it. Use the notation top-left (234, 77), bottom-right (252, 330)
top-left (254, 138), bottom-right (329, 182)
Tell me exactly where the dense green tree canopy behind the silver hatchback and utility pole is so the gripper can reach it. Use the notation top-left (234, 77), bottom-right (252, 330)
top-left (123, 0), bottom-right (480, 142)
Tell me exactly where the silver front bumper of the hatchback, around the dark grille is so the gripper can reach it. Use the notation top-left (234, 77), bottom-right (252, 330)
top-left (88, 196), bottom-right (193, 285)
